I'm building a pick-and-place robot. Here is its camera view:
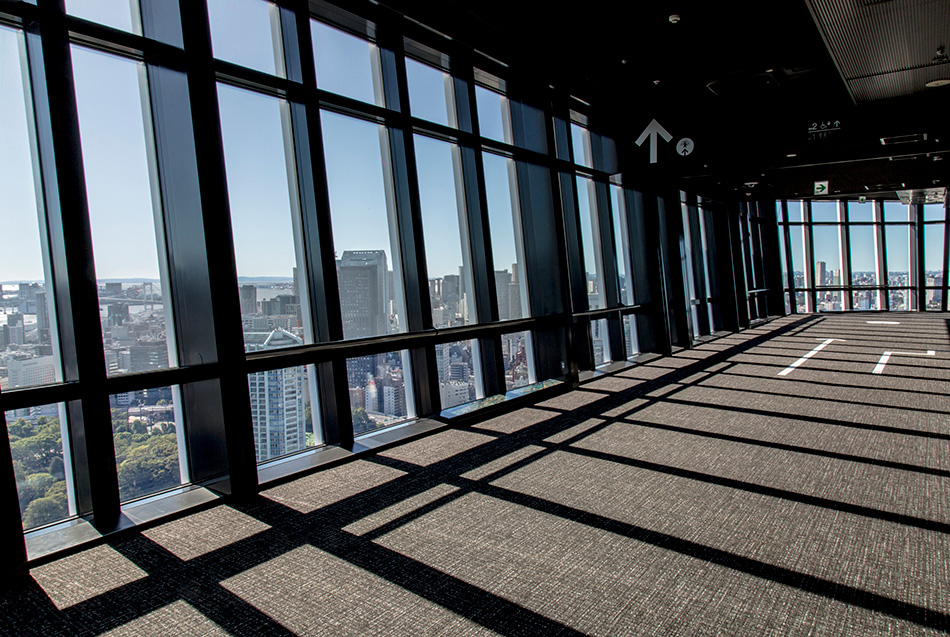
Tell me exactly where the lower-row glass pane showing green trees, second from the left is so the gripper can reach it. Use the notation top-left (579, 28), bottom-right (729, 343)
top-left (109, 387), bottom-right (188, 502)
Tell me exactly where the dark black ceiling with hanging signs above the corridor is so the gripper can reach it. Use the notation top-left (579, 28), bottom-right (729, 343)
top-left (384, 0), bottom-right (950, 197)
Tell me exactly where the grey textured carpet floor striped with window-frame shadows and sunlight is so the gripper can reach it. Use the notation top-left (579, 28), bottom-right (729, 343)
top-left (0, 314), bottom-right (950, 636)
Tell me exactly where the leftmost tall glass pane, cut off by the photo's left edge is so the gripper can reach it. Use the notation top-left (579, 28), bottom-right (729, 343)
top-left (0, 27), bottom-right (62, 390)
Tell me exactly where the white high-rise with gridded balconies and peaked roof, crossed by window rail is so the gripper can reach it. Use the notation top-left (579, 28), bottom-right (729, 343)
top-left (244, 329), bottom-right (307, 461)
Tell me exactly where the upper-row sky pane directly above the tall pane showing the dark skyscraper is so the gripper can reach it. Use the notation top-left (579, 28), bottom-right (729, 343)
top-left (310, 20), bottom-right (385, 106)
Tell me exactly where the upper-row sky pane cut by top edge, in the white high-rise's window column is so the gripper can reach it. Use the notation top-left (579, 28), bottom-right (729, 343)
top-left (208, 0), bottom-right (284, 77)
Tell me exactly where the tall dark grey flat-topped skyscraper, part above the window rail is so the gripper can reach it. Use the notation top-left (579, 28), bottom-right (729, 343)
top-left (337, 250), bottom-right (392, 338)
